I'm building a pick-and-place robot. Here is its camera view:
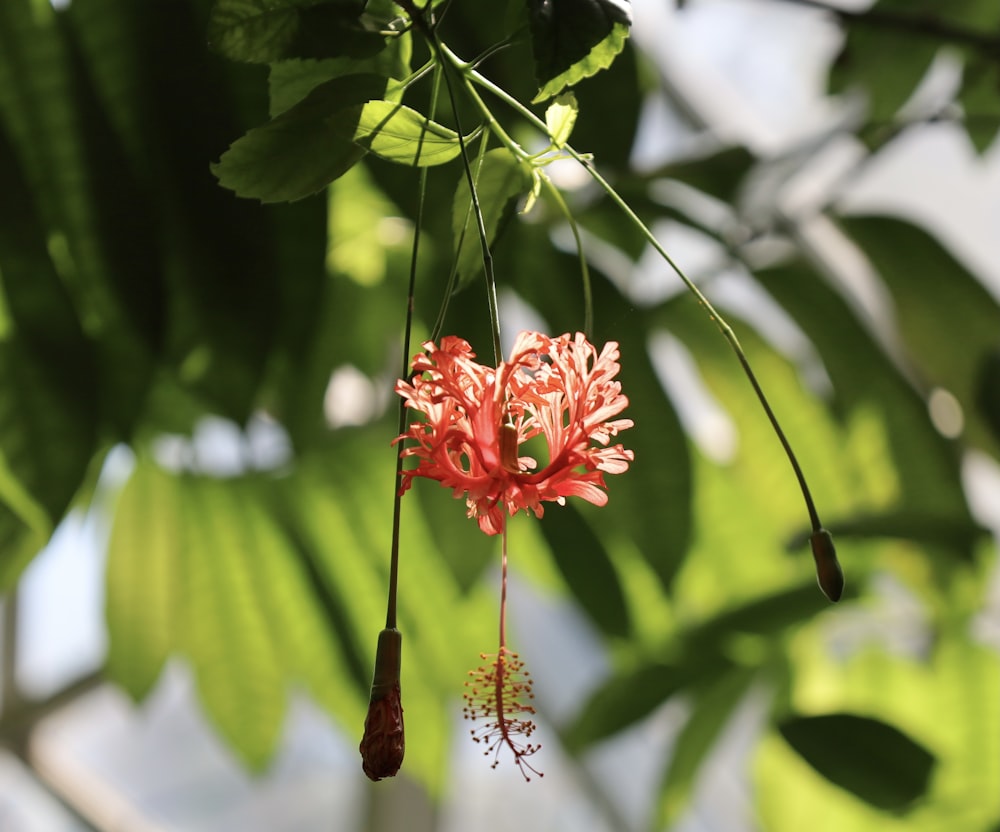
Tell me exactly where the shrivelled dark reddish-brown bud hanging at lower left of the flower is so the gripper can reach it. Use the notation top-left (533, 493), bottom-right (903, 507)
top-left (359, 628), bottom-right (406, 780)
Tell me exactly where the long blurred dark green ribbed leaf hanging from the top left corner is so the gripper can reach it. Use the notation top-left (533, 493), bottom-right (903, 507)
top-left (0, 0), bottom-right (160, 433)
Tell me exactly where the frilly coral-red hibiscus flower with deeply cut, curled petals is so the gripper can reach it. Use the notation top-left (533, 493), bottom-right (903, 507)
top-left (396, 332), bottom-right (634, 534)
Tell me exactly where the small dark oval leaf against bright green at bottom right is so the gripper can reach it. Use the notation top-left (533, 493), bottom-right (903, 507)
top-left (778, 713), bottom-right (936, 811)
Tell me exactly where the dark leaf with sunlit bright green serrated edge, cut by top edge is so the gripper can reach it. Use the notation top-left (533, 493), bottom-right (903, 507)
top-left (528, 0), bottom-right (632, 103)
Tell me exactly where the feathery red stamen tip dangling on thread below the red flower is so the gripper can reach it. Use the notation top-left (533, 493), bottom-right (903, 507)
top-left (462, 647), bottom-right (544, 780)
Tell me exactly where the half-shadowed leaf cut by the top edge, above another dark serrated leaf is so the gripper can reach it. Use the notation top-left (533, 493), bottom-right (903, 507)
top-left (208, 0), bottom-right (385, 63)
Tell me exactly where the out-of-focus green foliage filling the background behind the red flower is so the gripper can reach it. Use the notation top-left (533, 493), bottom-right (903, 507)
top-left (0, 0), bottom-right (1000, 832)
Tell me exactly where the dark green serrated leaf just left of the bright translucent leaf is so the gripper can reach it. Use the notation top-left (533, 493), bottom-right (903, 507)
top-left (212, 75), bottom-right (387, 202)
